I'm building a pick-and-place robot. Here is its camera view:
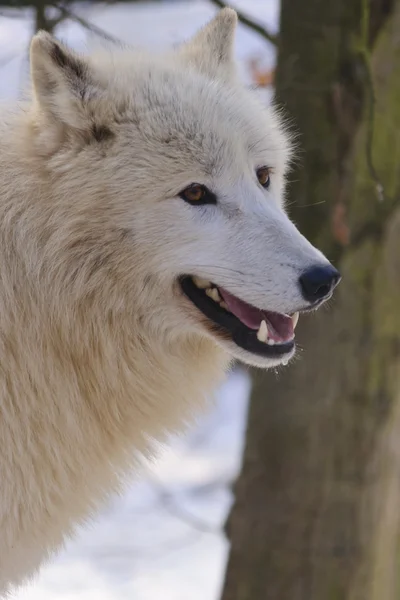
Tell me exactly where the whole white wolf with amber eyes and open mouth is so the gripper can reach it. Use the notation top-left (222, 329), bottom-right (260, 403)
top-left (0, 9), bottom-right (339, 595)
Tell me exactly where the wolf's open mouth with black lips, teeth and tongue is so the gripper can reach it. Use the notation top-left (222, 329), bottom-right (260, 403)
top-left (180, 276), bottom-right (299, 358)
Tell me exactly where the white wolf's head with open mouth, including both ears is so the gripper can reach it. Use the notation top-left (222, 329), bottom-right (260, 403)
top-left (31, 9), bottom-right (339, 367)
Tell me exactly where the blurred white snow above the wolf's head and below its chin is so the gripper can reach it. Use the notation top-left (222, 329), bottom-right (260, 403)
top-left (0, 0), bottom-right (278, 600)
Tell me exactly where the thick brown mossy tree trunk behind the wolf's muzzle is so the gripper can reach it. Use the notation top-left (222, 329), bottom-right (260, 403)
top-left (223, 0), bottom-right (400, 600)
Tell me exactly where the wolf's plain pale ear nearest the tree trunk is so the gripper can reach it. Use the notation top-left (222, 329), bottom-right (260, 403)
top-left (180, 8), bottom-right (237, 80)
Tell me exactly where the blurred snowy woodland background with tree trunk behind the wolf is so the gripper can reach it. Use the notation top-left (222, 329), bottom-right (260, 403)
top-left (0, 0), bottom-right (400, 600)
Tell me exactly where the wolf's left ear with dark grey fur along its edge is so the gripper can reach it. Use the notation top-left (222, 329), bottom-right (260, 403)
top-left (30, 31), bottom-right (98, 129)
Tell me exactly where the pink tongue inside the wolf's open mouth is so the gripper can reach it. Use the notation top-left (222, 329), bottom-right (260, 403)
top-left (218, 288), bottom-right (294, 343)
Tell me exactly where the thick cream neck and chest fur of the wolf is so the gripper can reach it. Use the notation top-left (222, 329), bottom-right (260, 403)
top-left (0, 110), bottom-right (227, 596)
